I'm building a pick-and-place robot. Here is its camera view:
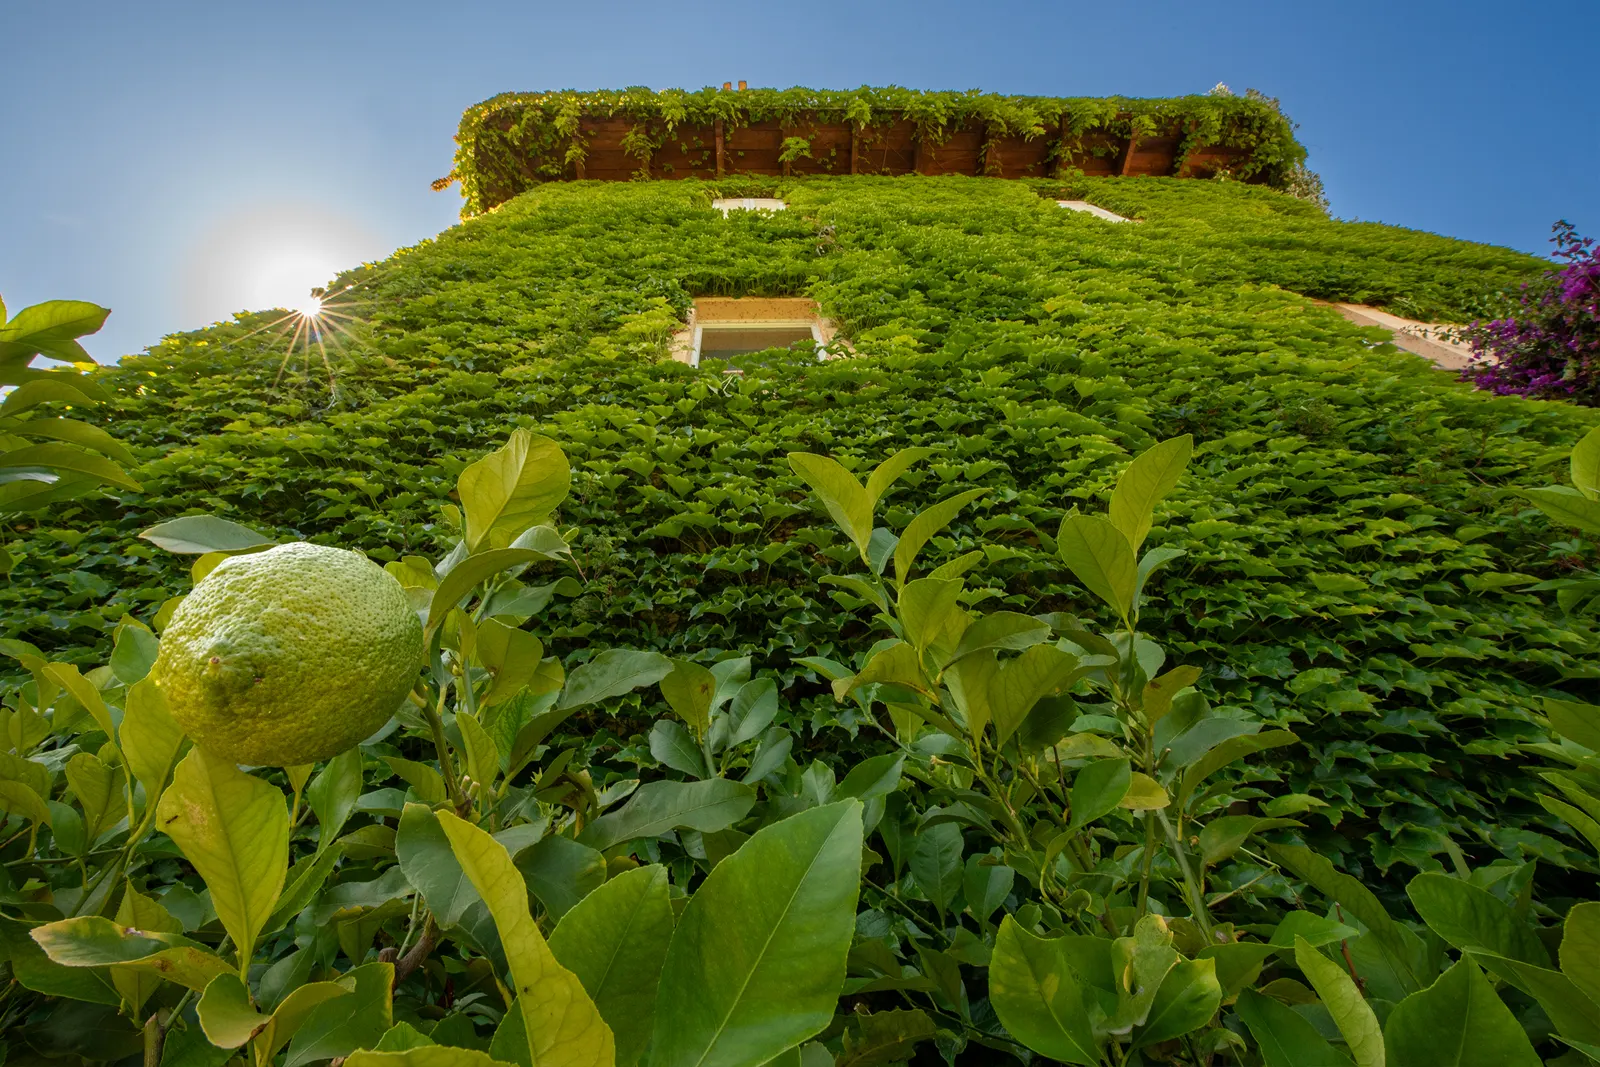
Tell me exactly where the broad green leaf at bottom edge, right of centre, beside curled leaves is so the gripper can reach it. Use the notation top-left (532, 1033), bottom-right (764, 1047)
top-left (989, 915), bottom-right (1101, 1065)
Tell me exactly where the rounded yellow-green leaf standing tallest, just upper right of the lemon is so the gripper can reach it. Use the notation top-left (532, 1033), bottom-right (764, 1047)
top-left (456, 429), bottom-right (573, 552)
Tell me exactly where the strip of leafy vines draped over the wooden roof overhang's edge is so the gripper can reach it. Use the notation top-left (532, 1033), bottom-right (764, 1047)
top-left (435, 86), bottom-right (1306, 218)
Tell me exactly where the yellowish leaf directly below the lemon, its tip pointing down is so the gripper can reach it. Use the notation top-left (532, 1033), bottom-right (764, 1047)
top-left (157, 749), bottom-right (290, 963)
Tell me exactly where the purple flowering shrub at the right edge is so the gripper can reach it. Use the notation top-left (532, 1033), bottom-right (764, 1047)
top-left (1464, 221), bottom-right (1600, 399)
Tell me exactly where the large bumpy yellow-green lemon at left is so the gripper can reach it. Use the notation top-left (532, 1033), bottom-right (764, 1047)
top-left (152, 542), bottom-right (422, 766)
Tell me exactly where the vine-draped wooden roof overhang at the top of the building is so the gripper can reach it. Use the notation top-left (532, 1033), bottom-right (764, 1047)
top-left (435, 86), bottom-right (1306, 216)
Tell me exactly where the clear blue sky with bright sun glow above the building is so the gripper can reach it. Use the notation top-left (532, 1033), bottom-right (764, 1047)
top-left (0, 0), bottom-right (1600, 362)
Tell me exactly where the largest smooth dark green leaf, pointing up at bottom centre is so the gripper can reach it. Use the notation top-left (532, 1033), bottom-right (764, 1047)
top-left (650, 800), bottom-right (861, 1067)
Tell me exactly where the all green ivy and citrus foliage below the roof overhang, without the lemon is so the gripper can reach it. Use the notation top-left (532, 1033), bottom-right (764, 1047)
top-left (0, 179), bottom-right (1600, 1067)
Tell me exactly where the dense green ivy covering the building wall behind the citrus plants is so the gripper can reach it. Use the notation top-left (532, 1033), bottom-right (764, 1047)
top-left (9, 178), bottom-right (1600, 902)
